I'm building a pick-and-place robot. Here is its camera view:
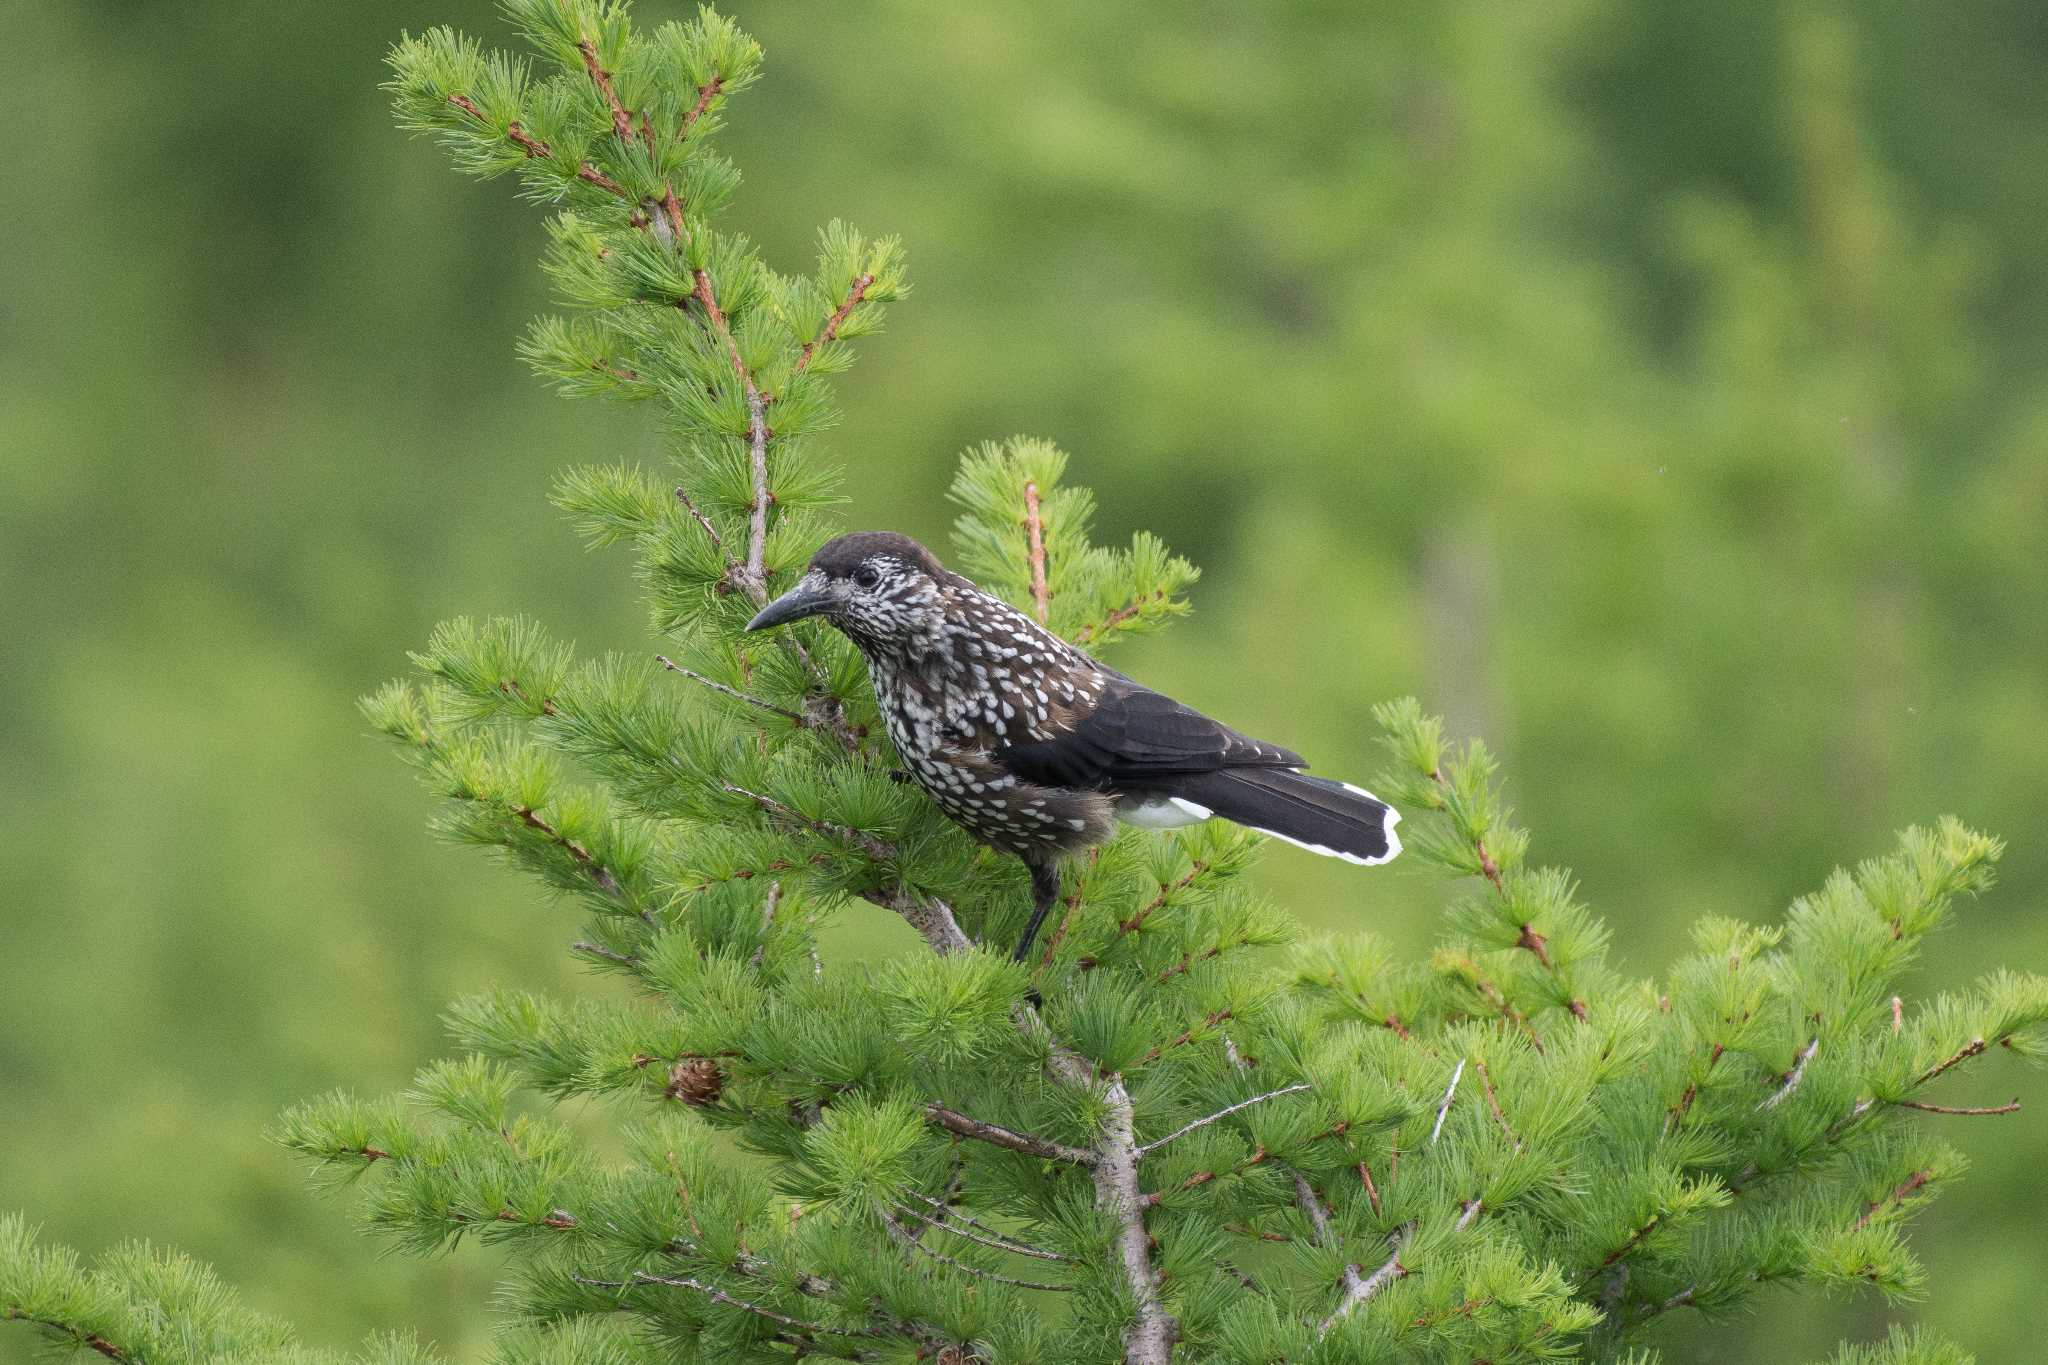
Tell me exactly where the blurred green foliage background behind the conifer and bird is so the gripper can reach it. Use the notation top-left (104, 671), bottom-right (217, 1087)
top-left (0, 0), bottom-right (2048, 1361)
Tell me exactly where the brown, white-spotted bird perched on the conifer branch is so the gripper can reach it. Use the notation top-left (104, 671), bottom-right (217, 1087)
top-left (748, 532), bottom-right (1401, 960)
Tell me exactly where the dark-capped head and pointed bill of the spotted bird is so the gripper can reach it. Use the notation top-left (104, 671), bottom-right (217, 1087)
top-left (748, 530), bottom-right (952, 653)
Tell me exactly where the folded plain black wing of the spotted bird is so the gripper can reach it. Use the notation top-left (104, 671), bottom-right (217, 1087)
top-left (993, 675), bottom-right (1307, 790)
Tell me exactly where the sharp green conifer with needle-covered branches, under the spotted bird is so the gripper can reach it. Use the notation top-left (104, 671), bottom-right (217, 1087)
top-left (0, 0), bottom-right (2048, 1365)
